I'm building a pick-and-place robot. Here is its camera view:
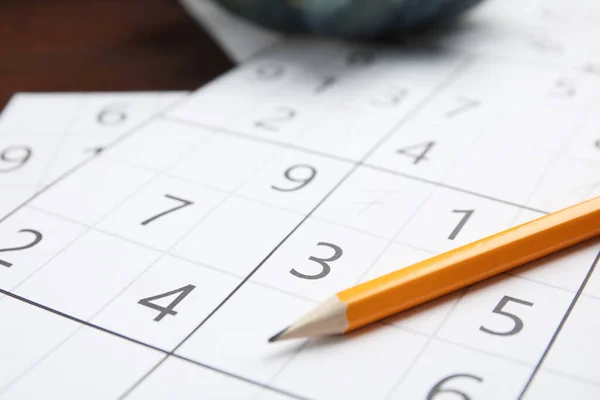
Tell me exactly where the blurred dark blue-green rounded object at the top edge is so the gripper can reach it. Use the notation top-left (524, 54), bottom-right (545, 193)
top-left (217, 0), bottom-right (482, 38)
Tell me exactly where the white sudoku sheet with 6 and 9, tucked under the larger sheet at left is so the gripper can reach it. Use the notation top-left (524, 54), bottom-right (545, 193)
top-left (0, 92), bottom-right (185, 216)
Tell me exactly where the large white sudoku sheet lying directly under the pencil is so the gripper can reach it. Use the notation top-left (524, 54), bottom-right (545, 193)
top-left (0, 1), bottom-right (600, 400)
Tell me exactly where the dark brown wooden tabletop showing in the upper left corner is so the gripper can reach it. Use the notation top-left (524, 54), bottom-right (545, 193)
top-left (0, 0), bottom-right (232, 110)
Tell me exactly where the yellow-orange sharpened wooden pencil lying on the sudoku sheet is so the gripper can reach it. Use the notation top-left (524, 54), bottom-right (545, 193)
top-left (269, 197), bottom-right (600, 342)
